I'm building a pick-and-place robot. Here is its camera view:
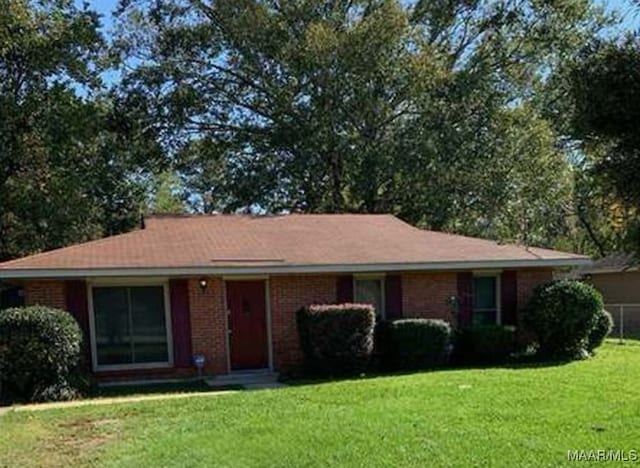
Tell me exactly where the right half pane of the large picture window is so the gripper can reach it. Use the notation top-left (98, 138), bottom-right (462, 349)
top-left (130, 286), bottom-right (169, 363)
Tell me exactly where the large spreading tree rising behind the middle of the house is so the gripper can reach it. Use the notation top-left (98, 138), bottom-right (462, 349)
top-left (117, 0), bottom-right (603, 249)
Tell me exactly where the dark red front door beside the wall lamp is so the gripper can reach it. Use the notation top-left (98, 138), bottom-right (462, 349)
top-left (226, 281), bottom-right (269, 370)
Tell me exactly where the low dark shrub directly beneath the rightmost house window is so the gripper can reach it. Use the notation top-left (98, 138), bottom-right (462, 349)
top-left (453, 325), bottom-right (517, 364)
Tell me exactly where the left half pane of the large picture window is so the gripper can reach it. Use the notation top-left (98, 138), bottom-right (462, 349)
top-left (93, 288), bottom-right (133, 366)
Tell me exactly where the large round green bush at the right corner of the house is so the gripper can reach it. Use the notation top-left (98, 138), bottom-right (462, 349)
top-left (523, 280), bottom-right (604, 359)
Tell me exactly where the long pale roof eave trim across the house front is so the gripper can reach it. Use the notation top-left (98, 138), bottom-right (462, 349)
top-left (0, 257), bottom-right (592, 279)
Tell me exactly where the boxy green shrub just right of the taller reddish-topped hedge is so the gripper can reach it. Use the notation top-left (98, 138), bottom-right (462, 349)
top-left (376, 318), bottom-right (452, 370)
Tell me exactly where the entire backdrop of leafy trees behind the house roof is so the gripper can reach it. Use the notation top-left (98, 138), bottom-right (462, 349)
top-left (0, 0), bottom-right (638, 259)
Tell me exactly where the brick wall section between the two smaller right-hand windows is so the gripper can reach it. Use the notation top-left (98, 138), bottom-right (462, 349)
top-left (402, 272), bottom-right (458, 325)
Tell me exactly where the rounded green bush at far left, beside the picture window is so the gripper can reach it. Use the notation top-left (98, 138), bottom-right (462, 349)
top-left (0, 306), bottom-right (82, 401)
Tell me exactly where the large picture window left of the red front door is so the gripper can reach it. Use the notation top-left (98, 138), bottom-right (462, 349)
top-left (92, 286), bottom-right (170, 367)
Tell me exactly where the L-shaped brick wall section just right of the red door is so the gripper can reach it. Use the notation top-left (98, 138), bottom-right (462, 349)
top-left (269, 275), bottom-right (337, 371)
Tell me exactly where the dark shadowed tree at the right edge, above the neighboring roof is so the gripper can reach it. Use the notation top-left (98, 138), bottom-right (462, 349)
top-left (567, 36), bottom-right (640, 255)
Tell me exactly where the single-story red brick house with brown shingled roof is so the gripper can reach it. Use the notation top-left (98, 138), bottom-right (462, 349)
top-left (0, 215), bottom-right (589, 379)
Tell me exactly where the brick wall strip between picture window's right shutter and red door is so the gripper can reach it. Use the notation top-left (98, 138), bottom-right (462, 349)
top-left (189, 278), bottom-right (228, 374)
